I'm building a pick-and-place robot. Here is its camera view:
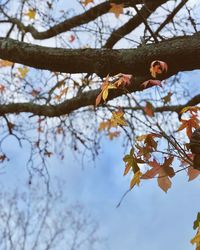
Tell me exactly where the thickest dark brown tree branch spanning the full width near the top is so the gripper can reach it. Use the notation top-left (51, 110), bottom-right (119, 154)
top-left (0, 33), bottom-right (200, 77)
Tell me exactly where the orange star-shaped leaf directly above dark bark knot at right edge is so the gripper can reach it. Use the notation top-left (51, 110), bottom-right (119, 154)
top-left (177, 115), bottom-right (200, 139)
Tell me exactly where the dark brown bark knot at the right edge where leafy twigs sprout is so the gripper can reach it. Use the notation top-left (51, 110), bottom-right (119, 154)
top-left (190, 128), bottom-right (200, 170)
